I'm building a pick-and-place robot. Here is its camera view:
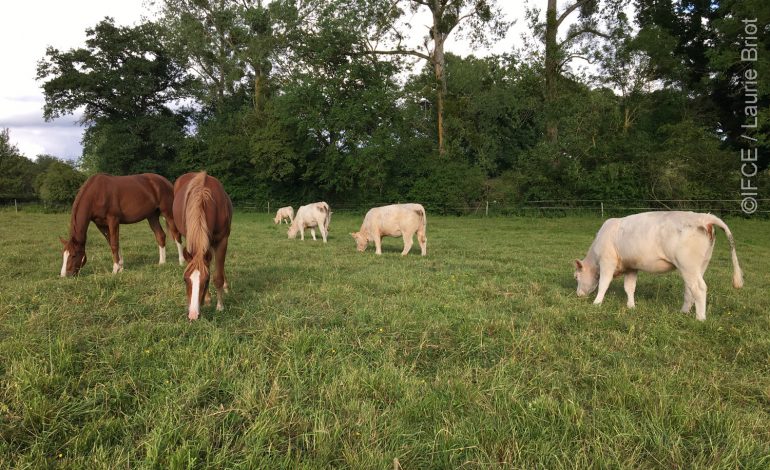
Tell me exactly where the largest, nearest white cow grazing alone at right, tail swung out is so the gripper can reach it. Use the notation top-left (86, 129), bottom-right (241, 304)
top-left (575, 211), bottom-right (743, 321)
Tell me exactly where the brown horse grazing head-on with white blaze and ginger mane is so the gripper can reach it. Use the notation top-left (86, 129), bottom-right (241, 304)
top-left (174, 171), bottom-right (233, 320)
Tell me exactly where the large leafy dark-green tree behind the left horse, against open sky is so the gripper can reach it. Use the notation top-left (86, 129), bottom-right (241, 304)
top-left (37, 18), bottom-right (190, 174)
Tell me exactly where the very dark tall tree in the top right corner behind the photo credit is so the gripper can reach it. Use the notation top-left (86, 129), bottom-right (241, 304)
top-left (635, 0), bottom-right (770, 168)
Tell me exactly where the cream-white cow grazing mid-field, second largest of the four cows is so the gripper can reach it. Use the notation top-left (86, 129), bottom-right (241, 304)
top-left (350, 204), bottom-right (428, 256)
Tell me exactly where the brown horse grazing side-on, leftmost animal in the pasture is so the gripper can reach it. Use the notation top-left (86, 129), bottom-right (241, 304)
top-left (60, 173), bottom-right (184, 277)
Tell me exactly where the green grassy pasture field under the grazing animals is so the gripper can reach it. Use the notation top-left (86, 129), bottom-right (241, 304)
top-left (0, 212), bottom-right (770, 469)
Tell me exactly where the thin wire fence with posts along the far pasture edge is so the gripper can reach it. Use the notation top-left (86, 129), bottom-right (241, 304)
top-left (0, 199), bottom-right (770, 218)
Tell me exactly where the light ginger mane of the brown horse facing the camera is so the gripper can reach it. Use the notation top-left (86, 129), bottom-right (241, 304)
top-left (185, 171), bottom-right (213, 271)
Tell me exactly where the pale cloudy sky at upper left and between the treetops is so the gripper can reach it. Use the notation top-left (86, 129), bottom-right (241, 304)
top-left (0, 0), bottom-right (526, 160)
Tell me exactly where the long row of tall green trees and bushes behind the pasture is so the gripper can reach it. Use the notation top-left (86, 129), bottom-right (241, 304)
top-left (21, 0), bottom-right (770, 212)
